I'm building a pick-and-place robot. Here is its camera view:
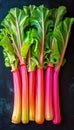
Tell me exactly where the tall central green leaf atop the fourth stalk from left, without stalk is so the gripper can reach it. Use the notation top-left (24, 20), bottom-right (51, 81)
top-left (30, 5), bottom-right (53, 66)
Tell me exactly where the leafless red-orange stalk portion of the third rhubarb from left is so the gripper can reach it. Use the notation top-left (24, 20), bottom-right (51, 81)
top-left (29, 71), bottom-right (35, 121)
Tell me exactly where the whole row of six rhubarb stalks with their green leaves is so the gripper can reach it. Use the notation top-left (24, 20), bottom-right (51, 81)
top-left (0, 5), bottom-right (74, 124)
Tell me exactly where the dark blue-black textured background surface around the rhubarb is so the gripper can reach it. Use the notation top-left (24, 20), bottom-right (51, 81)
top-left (0, 0), bottom-right (74, 130)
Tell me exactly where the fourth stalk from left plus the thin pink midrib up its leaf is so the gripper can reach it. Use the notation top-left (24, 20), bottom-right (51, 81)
top-left (35, 14), bottom-right (45, 124)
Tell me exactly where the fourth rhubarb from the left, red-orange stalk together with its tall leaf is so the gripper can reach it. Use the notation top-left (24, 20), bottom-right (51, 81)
top-left (30, 5), bottom-right (51, 124)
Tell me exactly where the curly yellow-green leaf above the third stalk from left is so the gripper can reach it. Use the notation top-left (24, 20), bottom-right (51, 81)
top-left (21, 5), bottom-right (39, 71)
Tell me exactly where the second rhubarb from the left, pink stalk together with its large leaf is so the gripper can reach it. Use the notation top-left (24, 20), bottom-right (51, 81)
top-left (2, 8), bottom-right (28, 123)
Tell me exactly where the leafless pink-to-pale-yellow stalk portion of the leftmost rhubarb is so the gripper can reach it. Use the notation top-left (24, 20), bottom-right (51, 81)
top-left (12, 69), bottom-right (22, 124)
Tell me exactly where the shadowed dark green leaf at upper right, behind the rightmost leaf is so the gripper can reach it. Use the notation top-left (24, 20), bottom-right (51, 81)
top-left (50, 6), bottom-right (67, 48)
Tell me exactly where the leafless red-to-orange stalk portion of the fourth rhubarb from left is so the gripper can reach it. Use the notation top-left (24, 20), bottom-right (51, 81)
top-left (35, 68), bottom-right (44, 124)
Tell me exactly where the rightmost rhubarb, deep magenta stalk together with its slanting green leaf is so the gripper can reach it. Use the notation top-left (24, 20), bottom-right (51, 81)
top-left (53, 18), bottom-right (74, 124)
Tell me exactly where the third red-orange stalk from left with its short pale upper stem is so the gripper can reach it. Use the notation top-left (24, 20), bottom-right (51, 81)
top-left (28, 48), bottom-right (36, 121)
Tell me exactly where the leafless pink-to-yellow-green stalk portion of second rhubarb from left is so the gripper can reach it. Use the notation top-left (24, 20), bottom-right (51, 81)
top-left (20, 64), bottom-right (29, 124)
